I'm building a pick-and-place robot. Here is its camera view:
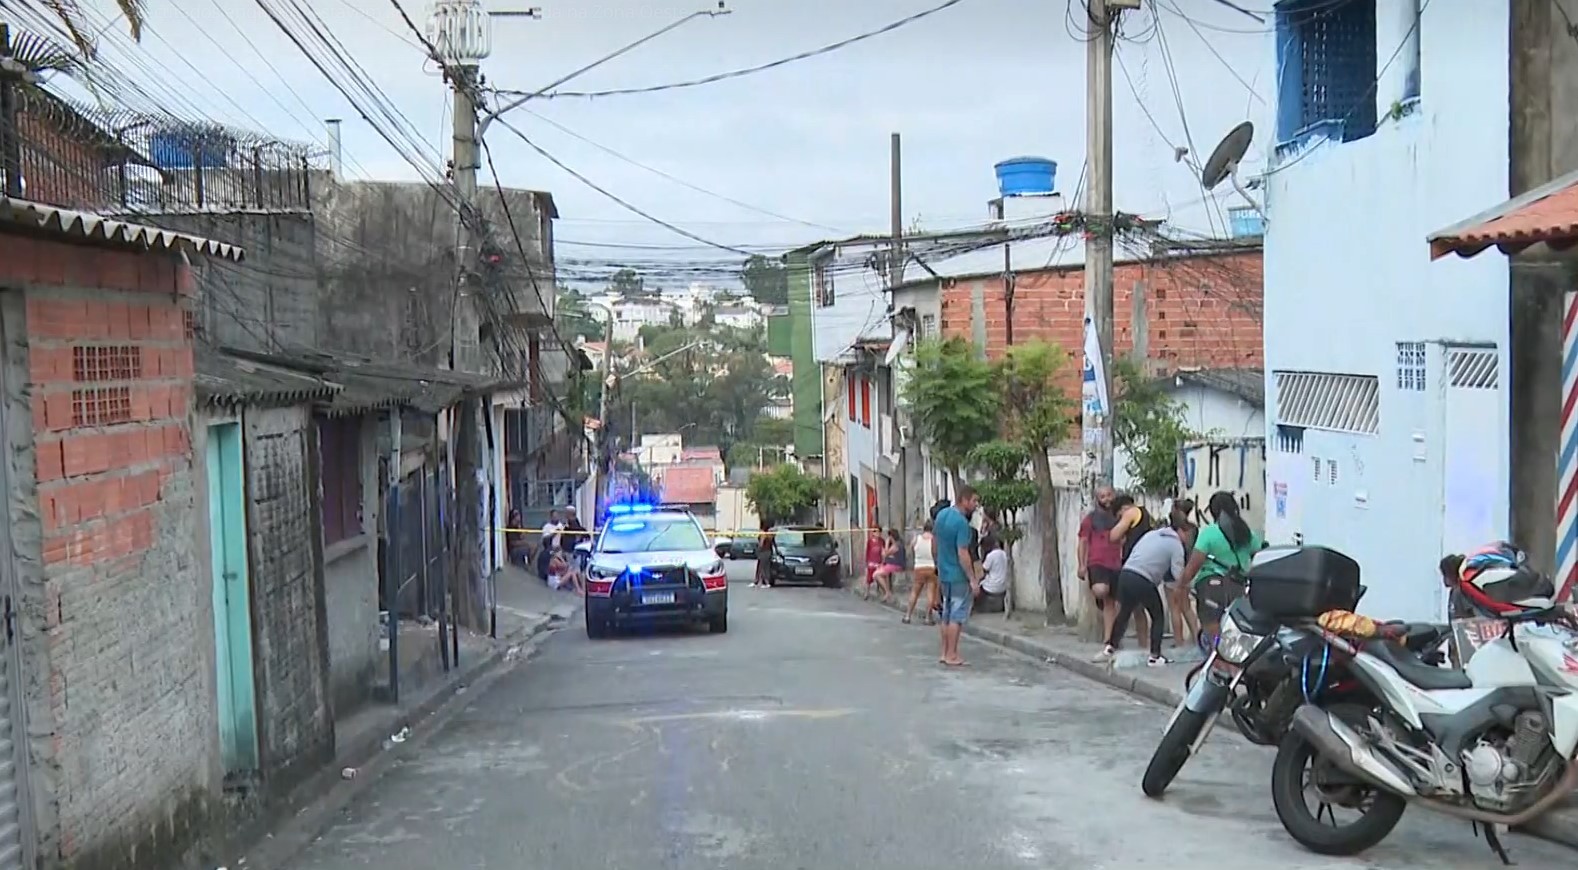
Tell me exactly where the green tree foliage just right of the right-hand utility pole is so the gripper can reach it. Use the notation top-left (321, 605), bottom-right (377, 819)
top-left (1112, 360), bottom-right (1190, 496)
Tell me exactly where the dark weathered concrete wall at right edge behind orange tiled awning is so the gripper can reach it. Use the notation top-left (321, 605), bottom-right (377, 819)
top-left (1495, 0), bottom-right (1578, 570)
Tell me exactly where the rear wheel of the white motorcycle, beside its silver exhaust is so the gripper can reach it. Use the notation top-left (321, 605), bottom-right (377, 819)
top-left (1272, 707), bottom-right (1408, 856)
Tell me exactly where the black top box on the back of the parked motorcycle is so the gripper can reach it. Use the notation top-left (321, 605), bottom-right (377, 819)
top-left (1247, 546), bottom-right (1362, 619)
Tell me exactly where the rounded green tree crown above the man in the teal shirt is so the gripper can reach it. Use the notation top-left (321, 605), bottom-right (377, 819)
top-left (903, 338), bottom-right (1002, 488)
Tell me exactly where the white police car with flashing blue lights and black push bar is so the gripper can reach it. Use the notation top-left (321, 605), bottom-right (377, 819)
top-left (585, 504), bottom-right (729, 638)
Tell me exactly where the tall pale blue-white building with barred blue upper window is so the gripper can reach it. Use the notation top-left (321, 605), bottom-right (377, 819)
top-left (1259, 0), bottom-right (1509, 619)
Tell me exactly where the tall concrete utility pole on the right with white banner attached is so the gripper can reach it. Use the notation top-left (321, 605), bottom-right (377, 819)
top-left (1081, 0), bottom-right (1139, 495)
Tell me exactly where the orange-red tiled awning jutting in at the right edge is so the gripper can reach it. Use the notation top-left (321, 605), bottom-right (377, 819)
top-left (1427, 172), bottom-right (1578, 259)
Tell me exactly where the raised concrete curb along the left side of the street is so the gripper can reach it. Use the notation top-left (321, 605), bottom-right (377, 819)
top-left (200, 616), bottom-right (567, 867)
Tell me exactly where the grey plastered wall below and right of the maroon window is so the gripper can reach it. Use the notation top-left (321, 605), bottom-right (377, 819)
top-left (320, 414), bottom-right (383, 717)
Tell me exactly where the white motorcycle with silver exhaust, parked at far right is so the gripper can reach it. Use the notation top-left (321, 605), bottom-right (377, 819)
top-left (1272, 598), bottom-right (1578, 864)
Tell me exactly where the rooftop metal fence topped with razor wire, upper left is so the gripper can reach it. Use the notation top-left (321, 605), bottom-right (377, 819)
top-left (0, 88), bottom-right (327, 215)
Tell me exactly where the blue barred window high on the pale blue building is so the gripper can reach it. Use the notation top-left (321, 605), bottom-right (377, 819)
top-left (1275, 0), bottom-right (1376, 142)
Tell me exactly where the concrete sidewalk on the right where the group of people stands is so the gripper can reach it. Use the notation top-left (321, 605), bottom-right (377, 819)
top-left (849, 579), bottom-right (1578, 849)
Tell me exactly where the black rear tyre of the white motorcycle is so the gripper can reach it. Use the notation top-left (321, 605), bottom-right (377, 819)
top-left (1272, 706), bottom-right (1408, 857)
